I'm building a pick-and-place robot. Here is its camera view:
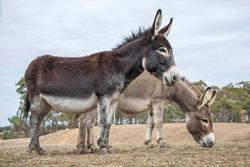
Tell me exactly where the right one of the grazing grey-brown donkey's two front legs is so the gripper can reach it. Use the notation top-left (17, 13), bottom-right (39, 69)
top-left (153, 101), bottom-right (166, 147)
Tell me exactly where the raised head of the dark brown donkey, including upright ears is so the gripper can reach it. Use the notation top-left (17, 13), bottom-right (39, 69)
top-left (142, 9), bottom-right (179, 86)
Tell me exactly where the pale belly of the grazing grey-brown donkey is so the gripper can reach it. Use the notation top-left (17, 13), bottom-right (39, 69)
top-left (118, 98), bottom-right (151, 114)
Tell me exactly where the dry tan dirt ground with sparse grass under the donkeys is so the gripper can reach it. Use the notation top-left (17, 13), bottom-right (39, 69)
top-left (0, 123), bottom-right (250, 167)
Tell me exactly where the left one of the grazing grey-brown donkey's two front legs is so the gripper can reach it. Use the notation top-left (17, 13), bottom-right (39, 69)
top-left (144, 110), bottom-right (155, 148)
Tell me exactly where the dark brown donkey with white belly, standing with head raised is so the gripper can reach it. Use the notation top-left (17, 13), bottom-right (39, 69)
top-left (24, 9), bottom-right (178, 154)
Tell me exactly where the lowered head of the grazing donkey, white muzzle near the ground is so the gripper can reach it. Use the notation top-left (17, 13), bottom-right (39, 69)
top-left (186, 87), bottom-right (217, 147)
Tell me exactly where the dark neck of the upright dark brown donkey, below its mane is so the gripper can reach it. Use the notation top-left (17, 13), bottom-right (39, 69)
top-left (114, 37), bottom-right (149, 87)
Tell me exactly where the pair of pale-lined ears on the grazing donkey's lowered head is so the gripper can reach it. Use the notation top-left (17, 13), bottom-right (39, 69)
top-left (198, 87), bottom-right (217, 108)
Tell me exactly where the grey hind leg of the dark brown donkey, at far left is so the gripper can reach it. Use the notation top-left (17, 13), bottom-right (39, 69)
top-left (29, 96), bottom-right (50, 155)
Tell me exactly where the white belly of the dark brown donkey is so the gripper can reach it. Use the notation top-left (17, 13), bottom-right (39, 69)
top-left (40, 94), bottom-right (96, 113)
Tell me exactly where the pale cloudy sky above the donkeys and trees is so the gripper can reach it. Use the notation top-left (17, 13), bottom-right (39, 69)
top-left (0, 0), bottom-right (250, 126)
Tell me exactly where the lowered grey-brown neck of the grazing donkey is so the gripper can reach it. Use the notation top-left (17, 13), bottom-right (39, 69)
top-left (169, 81), bottom-right (198, 112)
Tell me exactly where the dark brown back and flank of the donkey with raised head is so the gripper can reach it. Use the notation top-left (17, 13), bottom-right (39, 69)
top-left (25, 52), bottom-right (121, 98)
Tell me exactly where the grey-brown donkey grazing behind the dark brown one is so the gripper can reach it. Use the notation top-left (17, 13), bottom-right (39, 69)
top-left (77, 72), bottom-right (217, 153)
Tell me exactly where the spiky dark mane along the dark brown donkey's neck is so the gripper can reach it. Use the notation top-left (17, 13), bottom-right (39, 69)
top-left (115, 27), bottom-right (150, 49)
